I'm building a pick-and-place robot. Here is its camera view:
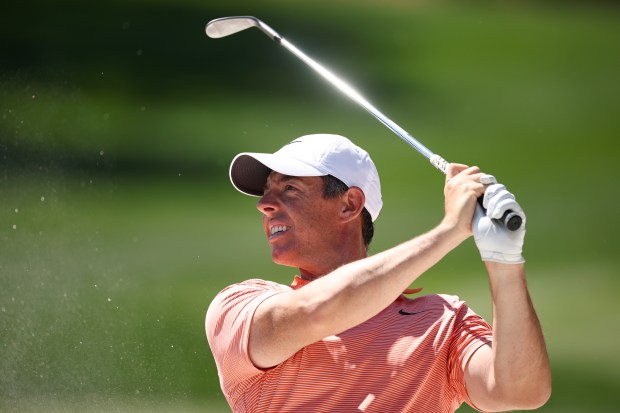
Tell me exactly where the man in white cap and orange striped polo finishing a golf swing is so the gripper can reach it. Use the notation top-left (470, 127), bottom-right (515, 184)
top-left (205, 135), bottom-right (551, 413)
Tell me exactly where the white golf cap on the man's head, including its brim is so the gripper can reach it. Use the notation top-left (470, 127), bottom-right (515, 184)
top-left (230, 134), bottom-right (383, 221)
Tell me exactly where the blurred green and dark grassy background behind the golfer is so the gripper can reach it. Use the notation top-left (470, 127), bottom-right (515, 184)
top-left (0, 0), bottom-right (620, 413)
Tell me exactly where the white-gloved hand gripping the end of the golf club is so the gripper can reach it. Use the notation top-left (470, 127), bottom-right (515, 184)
top-left (472, 175), bottom-right (525, 264)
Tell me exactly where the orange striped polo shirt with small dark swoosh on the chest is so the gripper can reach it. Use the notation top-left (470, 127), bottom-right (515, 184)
top-left (205, 277), bottom-right (492, 413)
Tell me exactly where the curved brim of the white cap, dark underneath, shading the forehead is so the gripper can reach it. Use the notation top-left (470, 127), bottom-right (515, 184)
top-left (230, 152), bottom-right (327, 196)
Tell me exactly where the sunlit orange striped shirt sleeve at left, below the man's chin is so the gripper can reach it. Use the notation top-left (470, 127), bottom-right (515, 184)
top-left (205, 280), bottom-right (287, 396)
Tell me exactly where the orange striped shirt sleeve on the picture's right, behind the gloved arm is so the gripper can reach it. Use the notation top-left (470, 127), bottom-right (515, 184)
top-left (448, 302), bottom-right (493, 411)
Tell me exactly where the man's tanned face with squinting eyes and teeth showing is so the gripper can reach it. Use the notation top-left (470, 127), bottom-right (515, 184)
top-left (257, 172), bottom-right (342, 275)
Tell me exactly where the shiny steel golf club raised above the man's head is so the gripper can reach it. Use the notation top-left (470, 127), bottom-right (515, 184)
top-left (205, 16), bottom-right (523, 231)
